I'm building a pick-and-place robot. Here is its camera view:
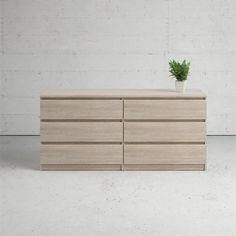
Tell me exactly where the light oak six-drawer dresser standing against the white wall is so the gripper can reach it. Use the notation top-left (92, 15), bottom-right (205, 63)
top-left (40, 90), bottom-right (206, 170)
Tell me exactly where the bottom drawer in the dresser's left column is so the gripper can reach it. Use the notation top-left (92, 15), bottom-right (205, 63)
top-left (40, 144), bottom-right (123, 164)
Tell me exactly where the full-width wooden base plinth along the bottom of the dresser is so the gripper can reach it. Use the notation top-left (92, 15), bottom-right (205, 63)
top-left (41, 164), bottom-right (206, 171)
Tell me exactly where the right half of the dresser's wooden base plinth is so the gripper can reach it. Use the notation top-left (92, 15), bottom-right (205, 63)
top-left (123, 164), bottom-right (205, 171)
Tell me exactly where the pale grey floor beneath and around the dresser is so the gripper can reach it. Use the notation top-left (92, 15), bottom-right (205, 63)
top-left (0, 136), bottom-right (236, 236)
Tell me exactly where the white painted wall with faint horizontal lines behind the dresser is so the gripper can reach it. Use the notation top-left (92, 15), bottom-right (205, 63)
top-left (0, 0), bottom-right (236, 134)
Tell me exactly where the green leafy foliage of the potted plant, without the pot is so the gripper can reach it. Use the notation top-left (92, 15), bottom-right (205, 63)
top-left (169, 60), bottom-right (190, 81)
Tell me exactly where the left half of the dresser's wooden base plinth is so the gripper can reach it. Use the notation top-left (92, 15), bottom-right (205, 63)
top-left (40, 164), bottom-right (121, 171)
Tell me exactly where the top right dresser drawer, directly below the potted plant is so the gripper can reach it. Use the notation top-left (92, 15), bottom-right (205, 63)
top-left (124, 100), bottom-right (206, 120)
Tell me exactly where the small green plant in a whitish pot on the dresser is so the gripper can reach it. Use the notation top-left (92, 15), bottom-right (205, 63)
top-left (169, 60), bottom-right (190, 93)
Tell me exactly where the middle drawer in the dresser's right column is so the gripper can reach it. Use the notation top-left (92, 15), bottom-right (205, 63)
top-left (124, 121), bottom-right (206, 142)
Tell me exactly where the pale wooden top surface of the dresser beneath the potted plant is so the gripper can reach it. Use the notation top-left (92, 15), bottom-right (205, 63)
top-left (41, 89), bottom-right (206, 98)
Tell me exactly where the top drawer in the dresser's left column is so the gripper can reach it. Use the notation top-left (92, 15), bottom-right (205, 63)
top-left (40, 99), bottom-right (123, 119)
